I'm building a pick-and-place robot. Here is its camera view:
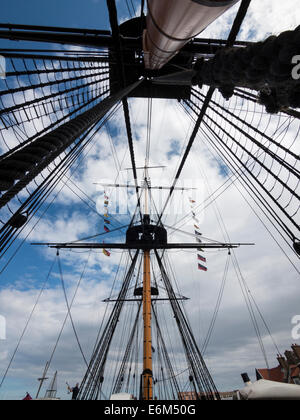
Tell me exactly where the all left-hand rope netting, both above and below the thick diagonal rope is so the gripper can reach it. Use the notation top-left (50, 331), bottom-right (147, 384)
top-left (0, 53), bottom-right (110, 262)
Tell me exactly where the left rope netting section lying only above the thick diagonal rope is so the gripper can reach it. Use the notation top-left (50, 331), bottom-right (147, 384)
top-left (0, 54), bottom-right (109, 155)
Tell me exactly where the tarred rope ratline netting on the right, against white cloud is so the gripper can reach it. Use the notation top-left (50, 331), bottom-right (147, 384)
top-left (183, 89), bottom-right (300, 254)
